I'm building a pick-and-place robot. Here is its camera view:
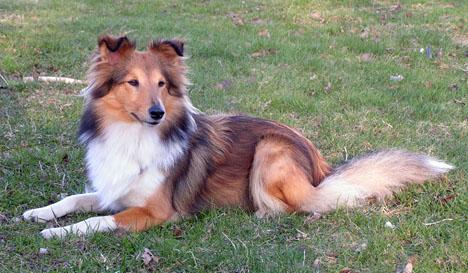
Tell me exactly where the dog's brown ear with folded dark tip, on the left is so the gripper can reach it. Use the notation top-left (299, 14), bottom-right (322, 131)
top-left (98, 35), bottom-right (135, 64)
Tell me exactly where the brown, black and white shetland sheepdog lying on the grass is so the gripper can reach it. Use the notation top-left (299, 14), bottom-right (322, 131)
top-left (23, 36), bottom-right (453, 238)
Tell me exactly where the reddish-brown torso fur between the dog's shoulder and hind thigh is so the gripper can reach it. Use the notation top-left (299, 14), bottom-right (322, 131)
top-left (169, 116), bottom-right (330, 214)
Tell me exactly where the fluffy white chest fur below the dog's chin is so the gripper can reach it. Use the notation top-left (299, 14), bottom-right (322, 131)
top-left (86, 123), bottom-right (184, 209)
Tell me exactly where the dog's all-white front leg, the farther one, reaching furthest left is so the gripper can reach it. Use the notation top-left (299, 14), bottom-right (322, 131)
top-left (23, 192), bottom-right (101, 222)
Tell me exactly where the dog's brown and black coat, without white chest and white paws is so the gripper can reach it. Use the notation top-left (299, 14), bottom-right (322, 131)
top-left (81, 36), bottom-right (450, 231)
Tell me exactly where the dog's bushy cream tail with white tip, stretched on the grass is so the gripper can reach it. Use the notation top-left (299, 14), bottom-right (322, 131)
top-left (310, 150), bottom-right (453, 212)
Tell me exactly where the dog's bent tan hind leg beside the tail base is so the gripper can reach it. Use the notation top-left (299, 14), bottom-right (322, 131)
top-left (250, 139), bottom-right (315, 217)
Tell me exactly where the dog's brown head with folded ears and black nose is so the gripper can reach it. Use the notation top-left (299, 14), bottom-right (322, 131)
top-left (87, 36), bottom-right (187, 126)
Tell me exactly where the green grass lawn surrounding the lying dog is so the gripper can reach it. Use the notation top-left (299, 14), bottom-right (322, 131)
top-left (0, 0), bottom-right (468, 272)
